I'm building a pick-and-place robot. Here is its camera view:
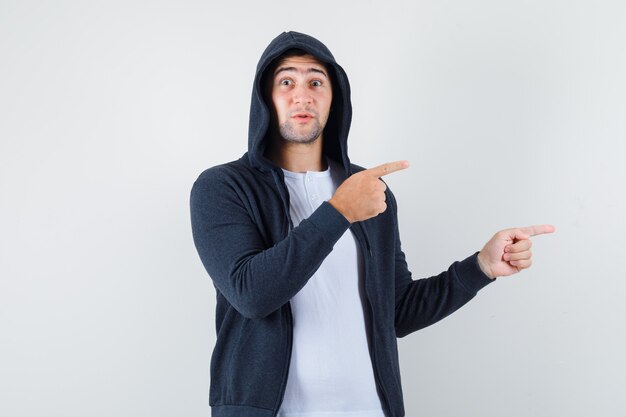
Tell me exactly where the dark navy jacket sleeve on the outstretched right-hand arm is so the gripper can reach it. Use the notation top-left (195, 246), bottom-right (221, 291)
top-left (389, 193), bottom-right (493, 337)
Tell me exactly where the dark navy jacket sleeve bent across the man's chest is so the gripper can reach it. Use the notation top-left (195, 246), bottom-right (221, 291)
top-left (190, 172), bottom-right (350, 318)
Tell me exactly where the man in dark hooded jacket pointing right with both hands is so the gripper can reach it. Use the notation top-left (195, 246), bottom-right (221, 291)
top-left (191, 32), bottom-right (554, 417)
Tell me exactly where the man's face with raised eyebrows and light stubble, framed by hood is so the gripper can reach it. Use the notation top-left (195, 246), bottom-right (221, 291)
top-left (271, 55), bottom-right (333, 144)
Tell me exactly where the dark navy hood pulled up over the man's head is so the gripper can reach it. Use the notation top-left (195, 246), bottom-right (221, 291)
top-left (248, 32), bottom-right (352, 173)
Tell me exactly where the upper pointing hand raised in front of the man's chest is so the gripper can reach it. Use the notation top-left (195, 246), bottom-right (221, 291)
top-left (328, 161), bottom-right (409, 223)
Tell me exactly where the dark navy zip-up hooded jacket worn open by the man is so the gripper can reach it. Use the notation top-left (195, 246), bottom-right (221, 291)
top-left (191, 32), bottom-right (492, 417)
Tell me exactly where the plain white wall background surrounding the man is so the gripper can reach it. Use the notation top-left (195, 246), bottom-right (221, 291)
top-left (0, 0), bottom-right (626, 417)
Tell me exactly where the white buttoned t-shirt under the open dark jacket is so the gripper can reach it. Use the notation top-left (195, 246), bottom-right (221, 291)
top-left (278, 164), bottom-right (384, 417)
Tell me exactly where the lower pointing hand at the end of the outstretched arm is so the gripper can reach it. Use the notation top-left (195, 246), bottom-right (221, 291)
top-left (478, 224), bottom-right (555, 279)
